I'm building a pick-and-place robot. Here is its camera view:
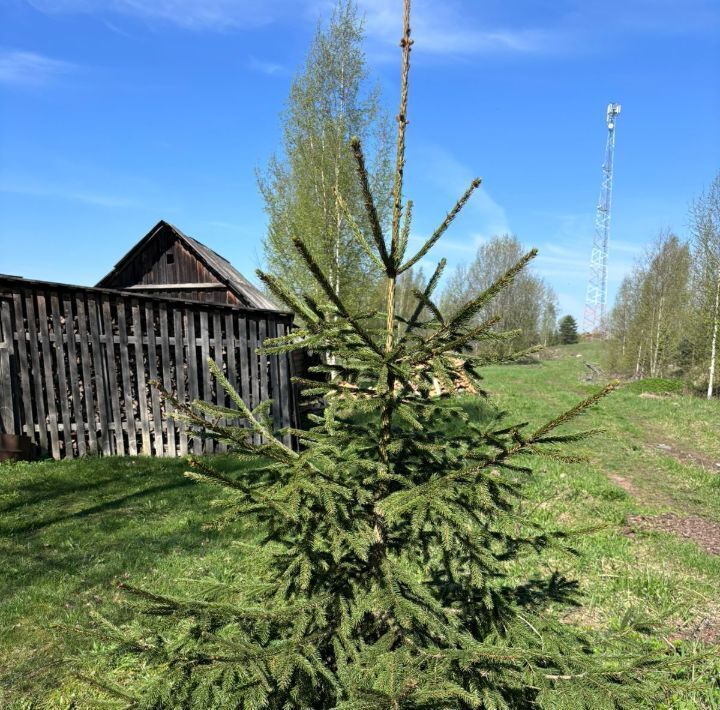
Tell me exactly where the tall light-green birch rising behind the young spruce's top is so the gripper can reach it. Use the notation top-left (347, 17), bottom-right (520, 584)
top-left (258, 0), bottom-right (392, 307)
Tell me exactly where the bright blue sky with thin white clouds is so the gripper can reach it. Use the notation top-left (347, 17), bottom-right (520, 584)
top-left (0, 0), bottom-right (720, 318)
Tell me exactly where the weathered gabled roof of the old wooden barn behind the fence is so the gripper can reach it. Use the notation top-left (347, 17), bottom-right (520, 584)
top-left (96, 219), bottom-right (280, 310)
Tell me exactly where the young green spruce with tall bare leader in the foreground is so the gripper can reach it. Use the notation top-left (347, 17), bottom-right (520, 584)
top-left (94, 0), bottom-right (676, 710)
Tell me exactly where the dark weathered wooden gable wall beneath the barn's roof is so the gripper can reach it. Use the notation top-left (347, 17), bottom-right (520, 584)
top-left (103, 229), bottom-right (239, 305)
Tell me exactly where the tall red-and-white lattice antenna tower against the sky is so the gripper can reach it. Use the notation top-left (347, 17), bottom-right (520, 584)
top-left (583, 103), bottom-right (620, 337)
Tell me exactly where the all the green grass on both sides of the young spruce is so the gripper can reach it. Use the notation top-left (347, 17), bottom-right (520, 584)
top-left (0, 344), bottom-right (720, 708)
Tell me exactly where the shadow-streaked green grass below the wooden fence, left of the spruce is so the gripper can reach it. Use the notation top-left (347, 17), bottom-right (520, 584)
top-left (0, 458), bottom-right (258, 708)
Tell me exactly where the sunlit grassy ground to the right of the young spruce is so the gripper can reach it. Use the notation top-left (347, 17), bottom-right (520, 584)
top-left (483, 344), bottom-right (720, 708)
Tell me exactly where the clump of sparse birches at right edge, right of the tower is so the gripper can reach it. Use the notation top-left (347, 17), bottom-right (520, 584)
top-left (609, 174), bottom-right (720, 398)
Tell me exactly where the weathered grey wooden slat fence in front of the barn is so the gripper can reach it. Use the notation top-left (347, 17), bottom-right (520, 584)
top-left (0, 277), bottom-right (297, 459)
